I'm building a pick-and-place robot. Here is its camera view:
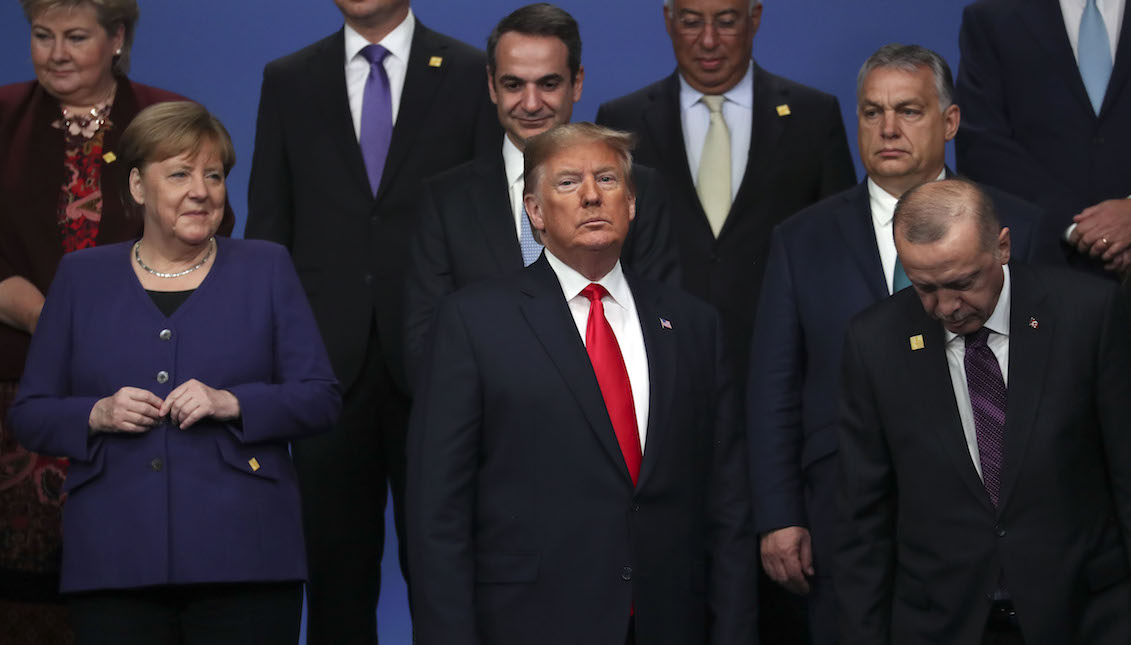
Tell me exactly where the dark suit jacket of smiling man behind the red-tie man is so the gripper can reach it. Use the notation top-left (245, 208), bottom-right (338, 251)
top-left (405, 154), bottom-right (680, 387)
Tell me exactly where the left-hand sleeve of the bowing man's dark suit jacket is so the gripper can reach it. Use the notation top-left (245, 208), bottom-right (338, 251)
top-left (834, 325), bottom-right (896, 645)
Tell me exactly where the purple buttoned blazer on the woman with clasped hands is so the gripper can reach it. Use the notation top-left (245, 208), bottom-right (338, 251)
top-left (9, 238), bottom-right (340, 592)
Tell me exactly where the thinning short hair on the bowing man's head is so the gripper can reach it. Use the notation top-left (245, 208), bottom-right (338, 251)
top-left (892, 178), bottom-right (1001, 251)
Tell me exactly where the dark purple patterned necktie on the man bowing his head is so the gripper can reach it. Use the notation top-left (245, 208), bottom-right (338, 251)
top-left (964, 327), bottom-right (1005, 507)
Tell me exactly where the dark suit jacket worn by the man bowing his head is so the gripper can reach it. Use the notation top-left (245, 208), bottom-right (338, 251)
top-left (836, 266), bottom-right (1131, 645)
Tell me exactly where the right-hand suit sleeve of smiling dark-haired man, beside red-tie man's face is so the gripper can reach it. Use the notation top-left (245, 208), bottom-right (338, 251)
top-left (621, 166), bottom-right (680, 286)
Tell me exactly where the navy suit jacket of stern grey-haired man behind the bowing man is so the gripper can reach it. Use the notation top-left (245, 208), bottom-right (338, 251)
top-left (746, 180), bottom-right (1064, 576)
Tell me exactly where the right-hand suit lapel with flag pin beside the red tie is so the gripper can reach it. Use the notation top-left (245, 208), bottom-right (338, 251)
top-left (625, 274), bottom-right (680, 489)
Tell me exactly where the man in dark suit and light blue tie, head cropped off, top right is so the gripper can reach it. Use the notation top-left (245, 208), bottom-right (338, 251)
top-left (956, 0), bottom-right (1131, 275)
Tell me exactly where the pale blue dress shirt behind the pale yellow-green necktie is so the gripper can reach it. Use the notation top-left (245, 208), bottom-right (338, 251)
top-left (680, 61), bottom-right (754, 201)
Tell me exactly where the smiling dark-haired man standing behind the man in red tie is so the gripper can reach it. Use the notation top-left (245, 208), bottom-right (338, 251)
top-left (405, 3), bottom-right (679, 382)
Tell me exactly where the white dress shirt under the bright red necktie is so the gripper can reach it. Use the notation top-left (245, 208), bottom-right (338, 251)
top-left (546, 249), bottom-right (649, 453)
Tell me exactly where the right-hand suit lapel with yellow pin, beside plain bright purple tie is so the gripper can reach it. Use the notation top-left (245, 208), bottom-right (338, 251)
top-left (377, 20), bottom-right (447, 200)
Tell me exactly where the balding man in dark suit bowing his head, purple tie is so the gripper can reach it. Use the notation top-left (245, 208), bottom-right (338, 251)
top-left (836, 179), bottom-right (1131, 645)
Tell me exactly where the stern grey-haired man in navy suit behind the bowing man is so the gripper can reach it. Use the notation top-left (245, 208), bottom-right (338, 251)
top-left (746, 44), bottom-right (1060, 645)
